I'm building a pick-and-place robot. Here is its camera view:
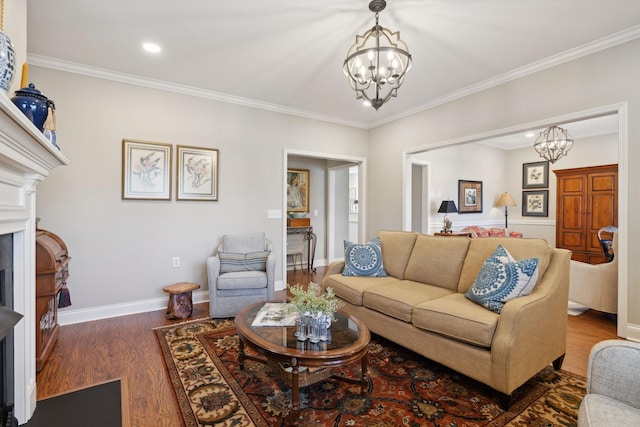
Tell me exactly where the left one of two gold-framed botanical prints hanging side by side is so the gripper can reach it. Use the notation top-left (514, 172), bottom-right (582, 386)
top-left (122, 139), bottom-right (173, 200)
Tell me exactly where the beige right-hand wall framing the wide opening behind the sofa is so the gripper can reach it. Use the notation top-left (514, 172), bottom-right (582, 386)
top-left (367, 40), bottom-right (640, 339)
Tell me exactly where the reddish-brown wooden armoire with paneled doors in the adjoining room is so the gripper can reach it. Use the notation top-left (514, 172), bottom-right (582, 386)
top-left (553, 165), bottom-right (618, 264)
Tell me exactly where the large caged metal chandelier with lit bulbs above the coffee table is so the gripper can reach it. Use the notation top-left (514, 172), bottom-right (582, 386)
top-left (342, 0), bottom-right (411, 110)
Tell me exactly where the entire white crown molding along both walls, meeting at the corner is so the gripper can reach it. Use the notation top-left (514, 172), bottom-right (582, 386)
top-left (27, 25), bottom-right (640, 129)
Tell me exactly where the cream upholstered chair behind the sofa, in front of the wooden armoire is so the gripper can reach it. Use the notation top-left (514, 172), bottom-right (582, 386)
top-left (569, 232), bottom-right (618, 314)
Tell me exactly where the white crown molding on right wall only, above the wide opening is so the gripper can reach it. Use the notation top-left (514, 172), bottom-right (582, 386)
top-left (369, 25), bottom-right (640, 128)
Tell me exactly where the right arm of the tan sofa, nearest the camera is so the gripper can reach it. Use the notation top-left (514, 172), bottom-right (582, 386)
top-left (491, 249), bottom-right (571, 394)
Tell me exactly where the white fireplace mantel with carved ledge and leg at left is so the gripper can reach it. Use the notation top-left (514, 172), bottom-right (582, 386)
top-left (0, 92), bottom-right (69, 424)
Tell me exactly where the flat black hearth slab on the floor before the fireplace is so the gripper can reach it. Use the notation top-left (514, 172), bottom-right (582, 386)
top-left (22, 380), bottom-right (122, 427)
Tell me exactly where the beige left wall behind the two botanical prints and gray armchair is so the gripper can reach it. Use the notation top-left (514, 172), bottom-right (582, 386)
top-left (31, 67), bottom-right (367, 322)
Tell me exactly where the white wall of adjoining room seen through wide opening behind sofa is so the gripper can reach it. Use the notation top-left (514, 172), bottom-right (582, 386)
top-left (413, 134), bottom-right (618, 245)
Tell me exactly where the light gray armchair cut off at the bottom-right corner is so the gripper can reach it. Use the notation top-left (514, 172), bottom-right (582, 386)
top-left (578, 340), bottom-right (640, 427)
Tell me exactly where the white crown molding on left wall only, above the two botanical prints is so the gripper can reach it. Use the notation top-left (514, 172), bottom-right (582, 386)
top-left (27, 53), bottom-right (369, 129)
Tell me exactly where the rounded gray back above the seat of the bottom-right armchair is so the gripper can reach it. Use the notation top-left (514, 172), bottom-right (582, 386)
top-left (587, 340), bottom-right (640, 409)
